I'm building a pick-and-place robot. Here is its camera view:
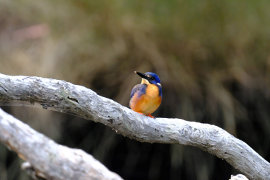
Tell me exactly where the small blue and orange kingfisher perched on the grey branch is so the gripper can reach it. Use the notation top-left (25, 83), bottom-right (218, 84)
top-left (129, 71), bottom-right (162, 118)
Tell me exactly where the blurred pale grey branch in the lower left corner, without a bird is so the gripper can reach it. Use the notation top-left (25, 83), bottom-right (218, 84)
top-left (0, 109), bottom-right (122, 180)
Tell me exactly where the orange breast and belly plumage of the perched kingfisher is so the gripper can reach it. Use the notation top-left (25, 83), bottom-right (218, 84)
top-left (130, 84), bottom-right (161, 115)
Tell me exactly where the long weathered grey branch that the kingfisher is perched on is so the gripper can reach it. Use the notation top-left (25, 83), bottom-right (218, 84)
top-left (0, 74), bottom-right (270, 179)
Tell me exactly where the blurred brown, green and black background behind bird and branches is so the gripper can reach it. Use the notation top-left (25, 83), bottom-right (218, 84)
top-left (0, 0), bottom-right (270, 180)
